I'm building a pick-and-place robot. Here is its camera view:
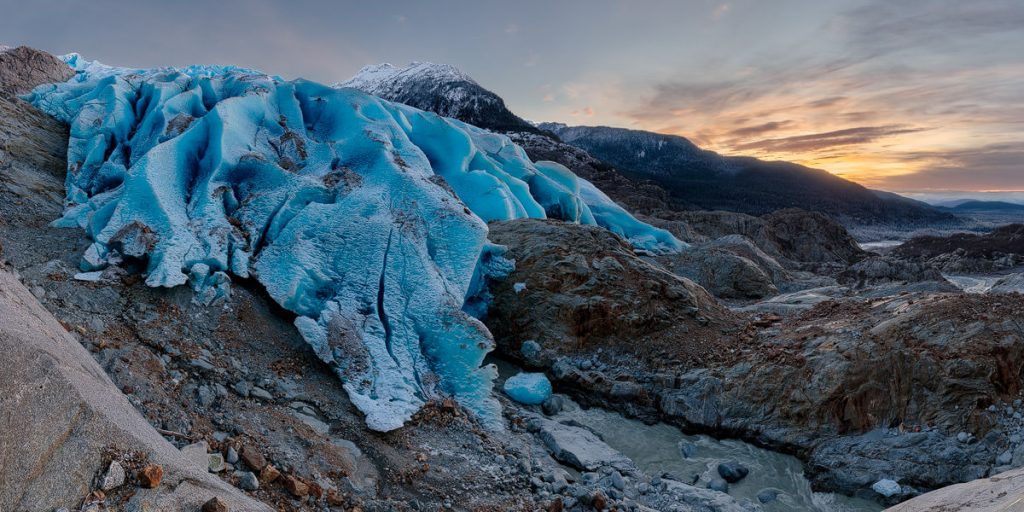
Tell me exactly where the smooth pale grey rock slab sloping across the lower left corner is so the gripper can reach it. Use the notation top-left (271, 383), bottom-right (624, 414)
top-left (0, 267), bottom-right (270, 512)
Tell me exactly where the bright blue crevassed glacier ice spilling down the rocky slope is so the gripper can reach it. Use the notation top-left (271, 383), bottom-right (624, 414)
top-left (27, 55), bottom-right (682, 430)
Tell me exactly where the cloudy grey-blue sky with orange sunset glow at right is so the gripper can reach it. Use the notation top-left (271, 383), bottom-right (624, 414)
top-left (0, 0), bottom-right (1024, 199)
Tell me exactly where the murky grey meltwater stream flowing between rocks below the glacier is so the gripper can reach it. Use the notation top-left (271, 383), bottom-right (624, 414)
top-left (488, 358), bottom-right (883, 512)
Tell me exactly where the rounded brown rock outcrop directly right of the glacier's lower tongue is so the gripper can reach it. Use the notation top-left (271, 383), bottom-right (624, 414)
top-left (486, 219), bottom-right (735, 365)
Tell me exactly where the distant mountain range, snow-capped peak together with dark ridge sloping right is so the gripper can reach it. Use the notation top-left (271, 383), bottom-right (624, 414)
top-left (336, 62), bottom-right (958, 225)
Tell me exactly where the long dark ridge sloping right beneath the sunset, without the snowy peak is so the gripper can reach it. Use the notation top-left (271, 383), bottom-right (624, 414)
top-left (539, 123), bottom-right (956, 224)
